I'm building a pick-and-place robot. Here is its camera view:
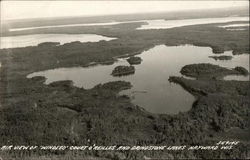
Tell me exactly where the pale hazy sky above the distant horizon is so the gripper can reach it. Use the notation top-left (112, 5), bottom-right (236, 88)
top-left (1, 1), bottom-right (249, 20)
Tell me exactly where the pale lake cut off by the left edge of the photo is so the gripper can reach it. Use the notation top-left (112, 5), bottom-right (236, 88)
top-left (0, 34), bottom-right (116, 49)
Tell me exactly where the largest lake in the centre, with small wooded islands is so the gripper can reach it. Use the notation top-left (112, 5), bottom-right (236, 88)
top-left (27, 45), bottom-right (249, 114)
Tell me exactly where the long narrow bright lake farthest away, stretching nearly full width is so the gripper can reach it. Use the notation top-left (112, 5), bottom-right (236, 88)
top-left (9, 17), bottom-right (249, 32)
